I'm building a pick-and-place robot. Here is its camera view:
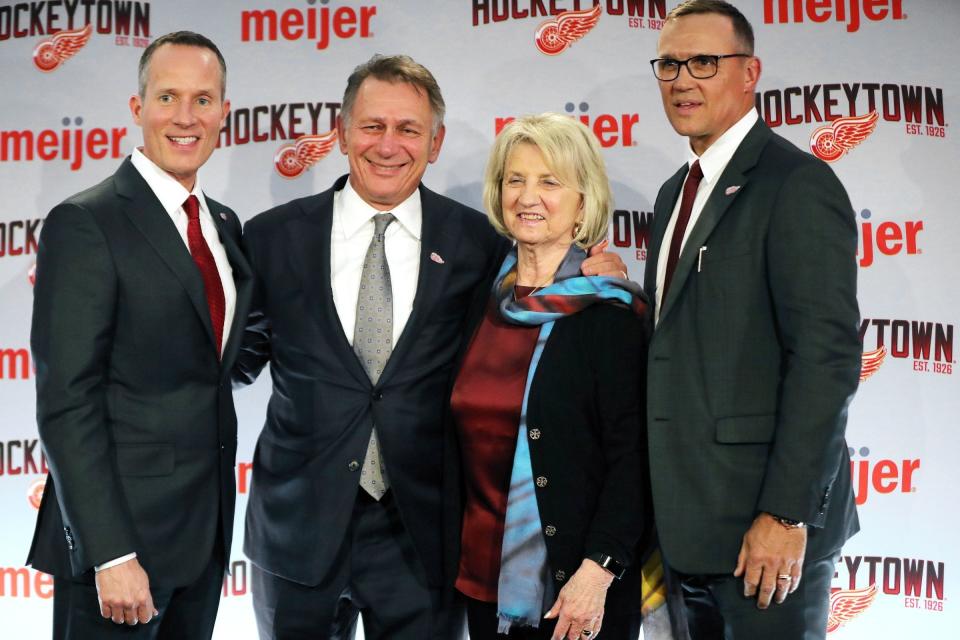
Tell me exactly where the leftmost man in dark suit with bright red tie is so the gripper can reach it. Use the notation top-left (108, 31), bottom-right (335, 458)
top-left (28, 32), bottom-right (252, 640)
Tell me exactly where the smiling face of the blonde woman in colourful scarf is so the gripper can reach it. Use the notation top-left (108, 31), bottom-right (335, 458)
top-left (501, 143), bottom-right (583, 253)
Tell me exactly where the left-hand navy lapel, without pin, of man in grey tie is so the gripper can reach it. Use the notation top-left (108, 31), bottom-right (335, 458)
top-left (288, 176), bottom-right (370, 387)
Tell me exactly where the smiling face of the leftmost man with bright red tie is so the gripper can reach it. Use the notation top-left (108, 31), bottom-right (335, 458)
top-left (130, 44), bottom-right (230, 190)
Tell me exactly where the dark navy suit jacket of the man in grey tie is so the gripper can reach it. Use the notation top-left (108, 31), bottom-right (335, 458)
top-left (237, 176), bottom-right (506, 586)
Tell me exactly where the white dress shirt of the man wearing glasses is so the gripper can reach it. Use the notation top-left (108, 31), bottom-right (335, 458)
top-left (656, 109), bottom-right (758, 322)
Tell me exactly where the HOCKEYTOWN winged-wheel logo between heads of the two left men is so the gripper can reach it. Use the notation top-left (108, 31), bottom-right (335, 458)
top-left (217, 102), bottom-right (340, 179)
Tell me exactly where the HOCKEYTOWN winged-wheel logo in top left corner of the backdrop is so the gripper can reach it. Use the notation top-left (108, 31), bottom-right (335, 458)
top-left (0, 0), bottom-right (150, 73)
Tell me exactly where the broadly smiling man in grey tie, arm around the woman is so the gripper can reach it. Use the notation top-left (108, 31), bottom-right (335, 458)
top-left (237, 56), bottom-right (622, 640)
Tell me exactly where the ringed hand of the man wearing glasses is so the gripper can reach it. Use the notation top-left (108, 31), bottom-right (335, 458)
top-left (733, 513), bottom-right (807, 609)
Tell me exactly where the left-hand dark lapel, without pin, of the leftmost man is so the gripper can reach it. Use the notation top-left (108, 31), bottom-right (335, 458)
top-left (115, 158), bottom-right (216, 348)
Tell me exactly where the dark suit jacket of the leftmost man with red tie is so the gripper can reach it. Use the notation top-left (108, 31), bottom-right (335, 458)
top-left (27, 158), bottom-right (251, 587)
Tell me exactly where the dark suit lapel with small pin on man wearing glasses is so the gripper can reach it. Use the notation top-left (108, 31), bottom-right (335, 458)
top-left (660, 121), bottom-right (770, 322)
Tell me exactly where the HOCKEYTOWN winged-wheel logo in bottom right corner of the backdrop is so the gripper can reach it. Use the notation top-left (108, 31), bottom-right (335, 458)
top-left (827, 556), bottom-right (946, 632)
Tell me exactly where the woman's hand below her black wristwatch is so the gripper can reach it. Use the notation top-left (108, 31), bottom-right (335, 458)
top-left (544, 559), bottom-right (613, 640)
